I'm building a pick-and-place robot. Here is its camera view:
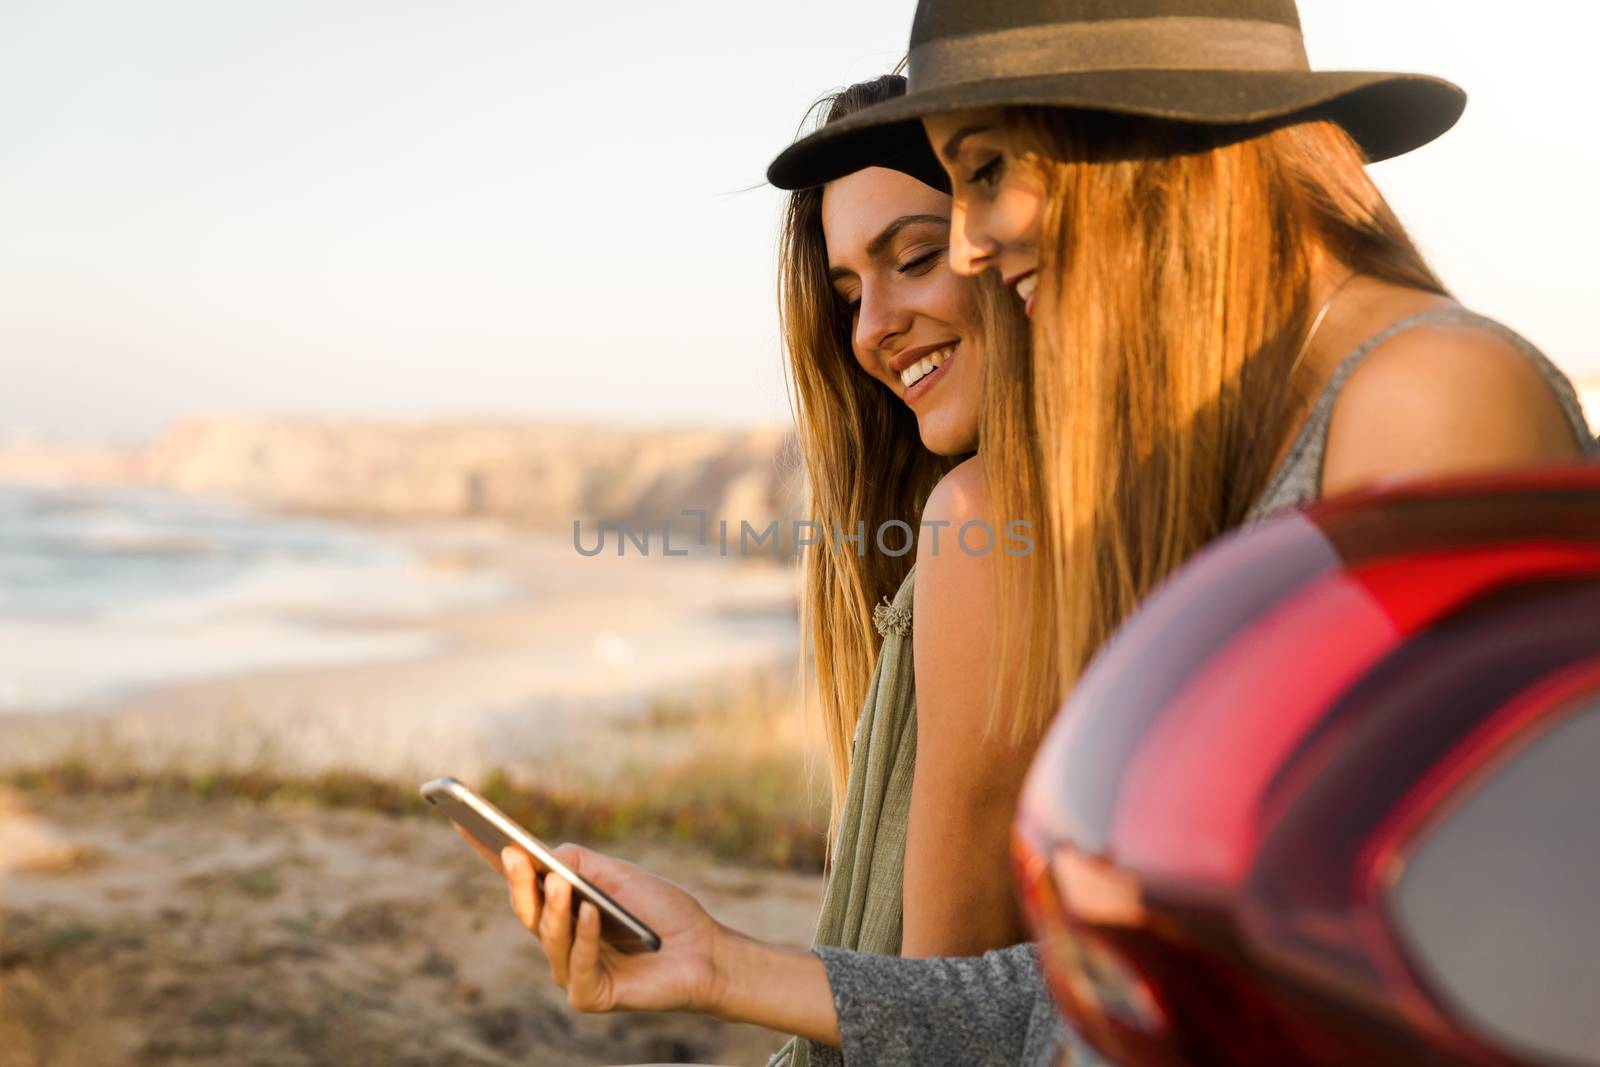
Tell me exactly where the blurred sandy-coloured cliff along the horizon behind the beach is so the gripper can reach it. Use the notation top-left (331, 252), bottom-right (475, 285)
top-left (0, 416), bottom-right (802, 534)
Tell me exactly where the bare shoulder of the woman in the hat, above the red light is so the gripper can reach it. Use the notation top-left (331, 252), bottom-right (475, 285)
top-left (1322, 326), bottom-right (1581, 496)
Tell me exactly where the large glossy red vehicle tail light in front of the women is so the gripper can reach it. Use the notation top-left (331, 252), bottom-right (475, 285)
top-left (1014, 467), bottom-right (1600, 1067)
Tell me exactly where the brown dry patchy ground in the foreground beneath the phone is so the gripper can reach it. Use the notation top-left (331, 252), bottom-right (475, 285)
top-left (0, 792), bottom-right (821, 1067)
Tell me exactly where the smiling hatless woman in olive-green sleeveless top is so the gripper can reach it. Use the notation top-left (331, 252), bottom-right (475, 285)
top-left (480, 75), bottom-right (1056, 1067)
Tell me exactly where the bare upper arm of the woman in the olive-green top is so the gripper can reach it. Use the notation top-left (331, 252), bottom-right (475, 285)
top-left (901, 458), bottom-right (1032, 957)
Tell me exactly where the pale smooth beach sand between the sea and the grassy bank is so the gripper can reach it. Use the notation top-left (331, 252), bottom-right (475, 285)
top-left (0, 523), bottom-right (798, 785)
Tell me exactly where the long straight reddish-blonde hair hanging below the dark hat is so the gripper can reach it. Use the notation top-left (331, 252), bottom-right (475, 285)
top-left (982, 109), bottom-right (1443, 736)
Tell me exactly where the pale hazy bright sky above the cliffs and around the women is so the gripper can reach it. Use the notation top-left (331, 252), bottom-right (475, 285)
top-left (0, 0), bottom-right (1600, 440)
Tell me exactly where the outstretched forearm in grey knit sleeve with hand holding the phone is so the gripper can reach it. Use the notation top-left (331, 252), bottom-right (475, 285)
top-left (485, 845), bottom-right (1062, 1067)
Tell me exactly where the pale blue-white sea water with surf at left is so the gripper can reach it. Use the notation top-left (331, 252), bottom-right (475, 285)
top-left (0, 486), bottom-right (506, 713)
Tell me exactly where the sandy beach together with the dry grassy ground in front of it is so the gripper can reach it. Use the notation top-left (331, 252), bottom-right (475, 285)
top-left (0, 495), bottom-right (826, 1067)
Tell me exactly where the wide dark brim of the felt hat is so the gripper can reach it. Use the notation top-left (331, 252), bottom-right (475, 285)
top-left (766, 70), bottom-right (1467, 189)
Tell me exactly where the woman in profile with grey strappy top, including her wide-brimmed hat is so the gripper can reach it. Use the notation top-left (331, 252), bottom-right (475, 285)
top-left (770, 0), bottom-right (1592, 748)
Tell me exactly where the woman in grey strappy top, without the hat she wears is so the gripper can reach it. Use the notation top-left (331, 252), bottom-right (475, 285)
top-left (923, 107), bottom-right (1590, 751)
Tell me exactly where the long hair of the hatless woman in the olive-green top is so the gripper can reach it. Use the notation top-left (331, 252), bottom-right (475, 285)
top-left (778, 75), bottom-right (1026, 837)
